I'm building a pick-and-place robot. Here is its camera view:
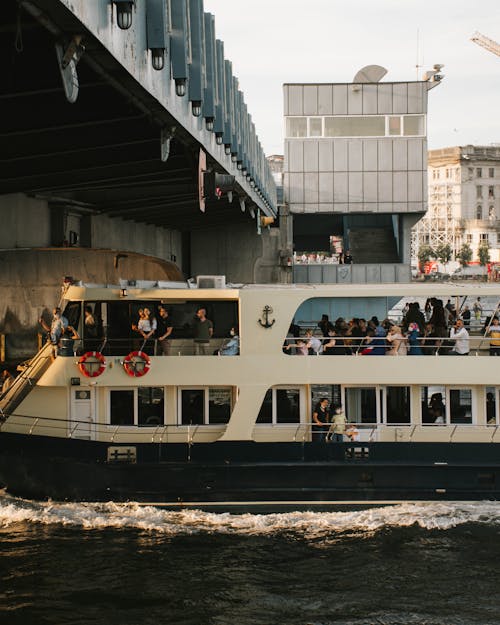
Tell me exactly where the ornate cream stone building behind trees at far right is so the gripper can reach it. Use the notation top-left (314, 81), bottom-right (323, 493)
top-left (414, 145), bottom-right (500, 262)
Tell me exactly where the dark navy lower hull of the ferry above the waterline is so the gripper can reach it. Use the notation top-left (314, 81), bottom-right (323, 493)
top-left (0, 433), bottom-right (500, 510)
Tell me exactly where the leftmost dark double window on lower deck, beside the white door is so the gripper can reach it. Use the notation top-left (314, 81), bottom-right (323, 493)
top-left (109, 387), bottom-right (164, 427)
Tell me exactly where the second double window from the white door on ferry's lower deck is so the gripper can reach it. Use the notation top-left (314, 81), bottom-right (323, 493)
top-left (180, 387), bottom-right (233, 425)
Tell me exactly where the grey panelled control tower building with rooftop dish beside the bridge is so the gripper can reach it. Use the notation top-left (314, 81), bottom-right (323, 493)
top-left (283, 66), bottom-right (441, 282)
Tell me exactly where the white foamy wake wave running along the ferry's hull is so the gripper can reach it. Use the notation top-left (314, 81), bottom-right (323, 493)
top-left (0, 495), bottom-right (500, 538)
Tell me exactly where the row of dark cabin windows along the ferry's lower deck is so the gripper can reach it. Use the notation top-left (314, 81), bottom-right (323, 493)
top-left (109, 385), bottom-right (500, 427)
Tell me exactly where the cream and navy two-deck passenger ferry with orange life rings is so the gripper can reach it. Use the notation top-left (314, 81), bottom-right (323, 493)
top-left (0, 279), bottom-right (500, 509)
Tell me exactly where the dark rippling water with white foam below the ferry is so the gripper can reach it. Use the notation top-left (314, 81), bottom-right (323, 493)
top-left (0, 495), bottom-right (500, 625)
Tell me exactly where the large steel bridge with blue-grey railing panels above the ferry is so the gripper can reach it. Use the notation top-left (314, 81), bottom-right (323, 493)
top-left (0, 0), bottom-right (286, 360)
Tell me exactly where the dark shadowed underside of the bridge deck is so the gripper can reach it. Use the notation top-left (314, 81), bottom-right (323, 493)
top-left (0, 0), bottom-right (251, 231)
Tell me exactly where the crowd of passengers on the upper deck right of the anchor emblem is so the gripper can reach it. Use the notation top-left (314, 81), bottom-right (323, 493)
top-left (283, 297), bottom-right (500, 356)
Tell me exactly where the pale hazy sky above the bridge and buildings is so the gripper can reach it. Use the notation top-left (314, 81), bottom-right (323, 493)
top-left (204, 0), bottom-right (500, 156)
